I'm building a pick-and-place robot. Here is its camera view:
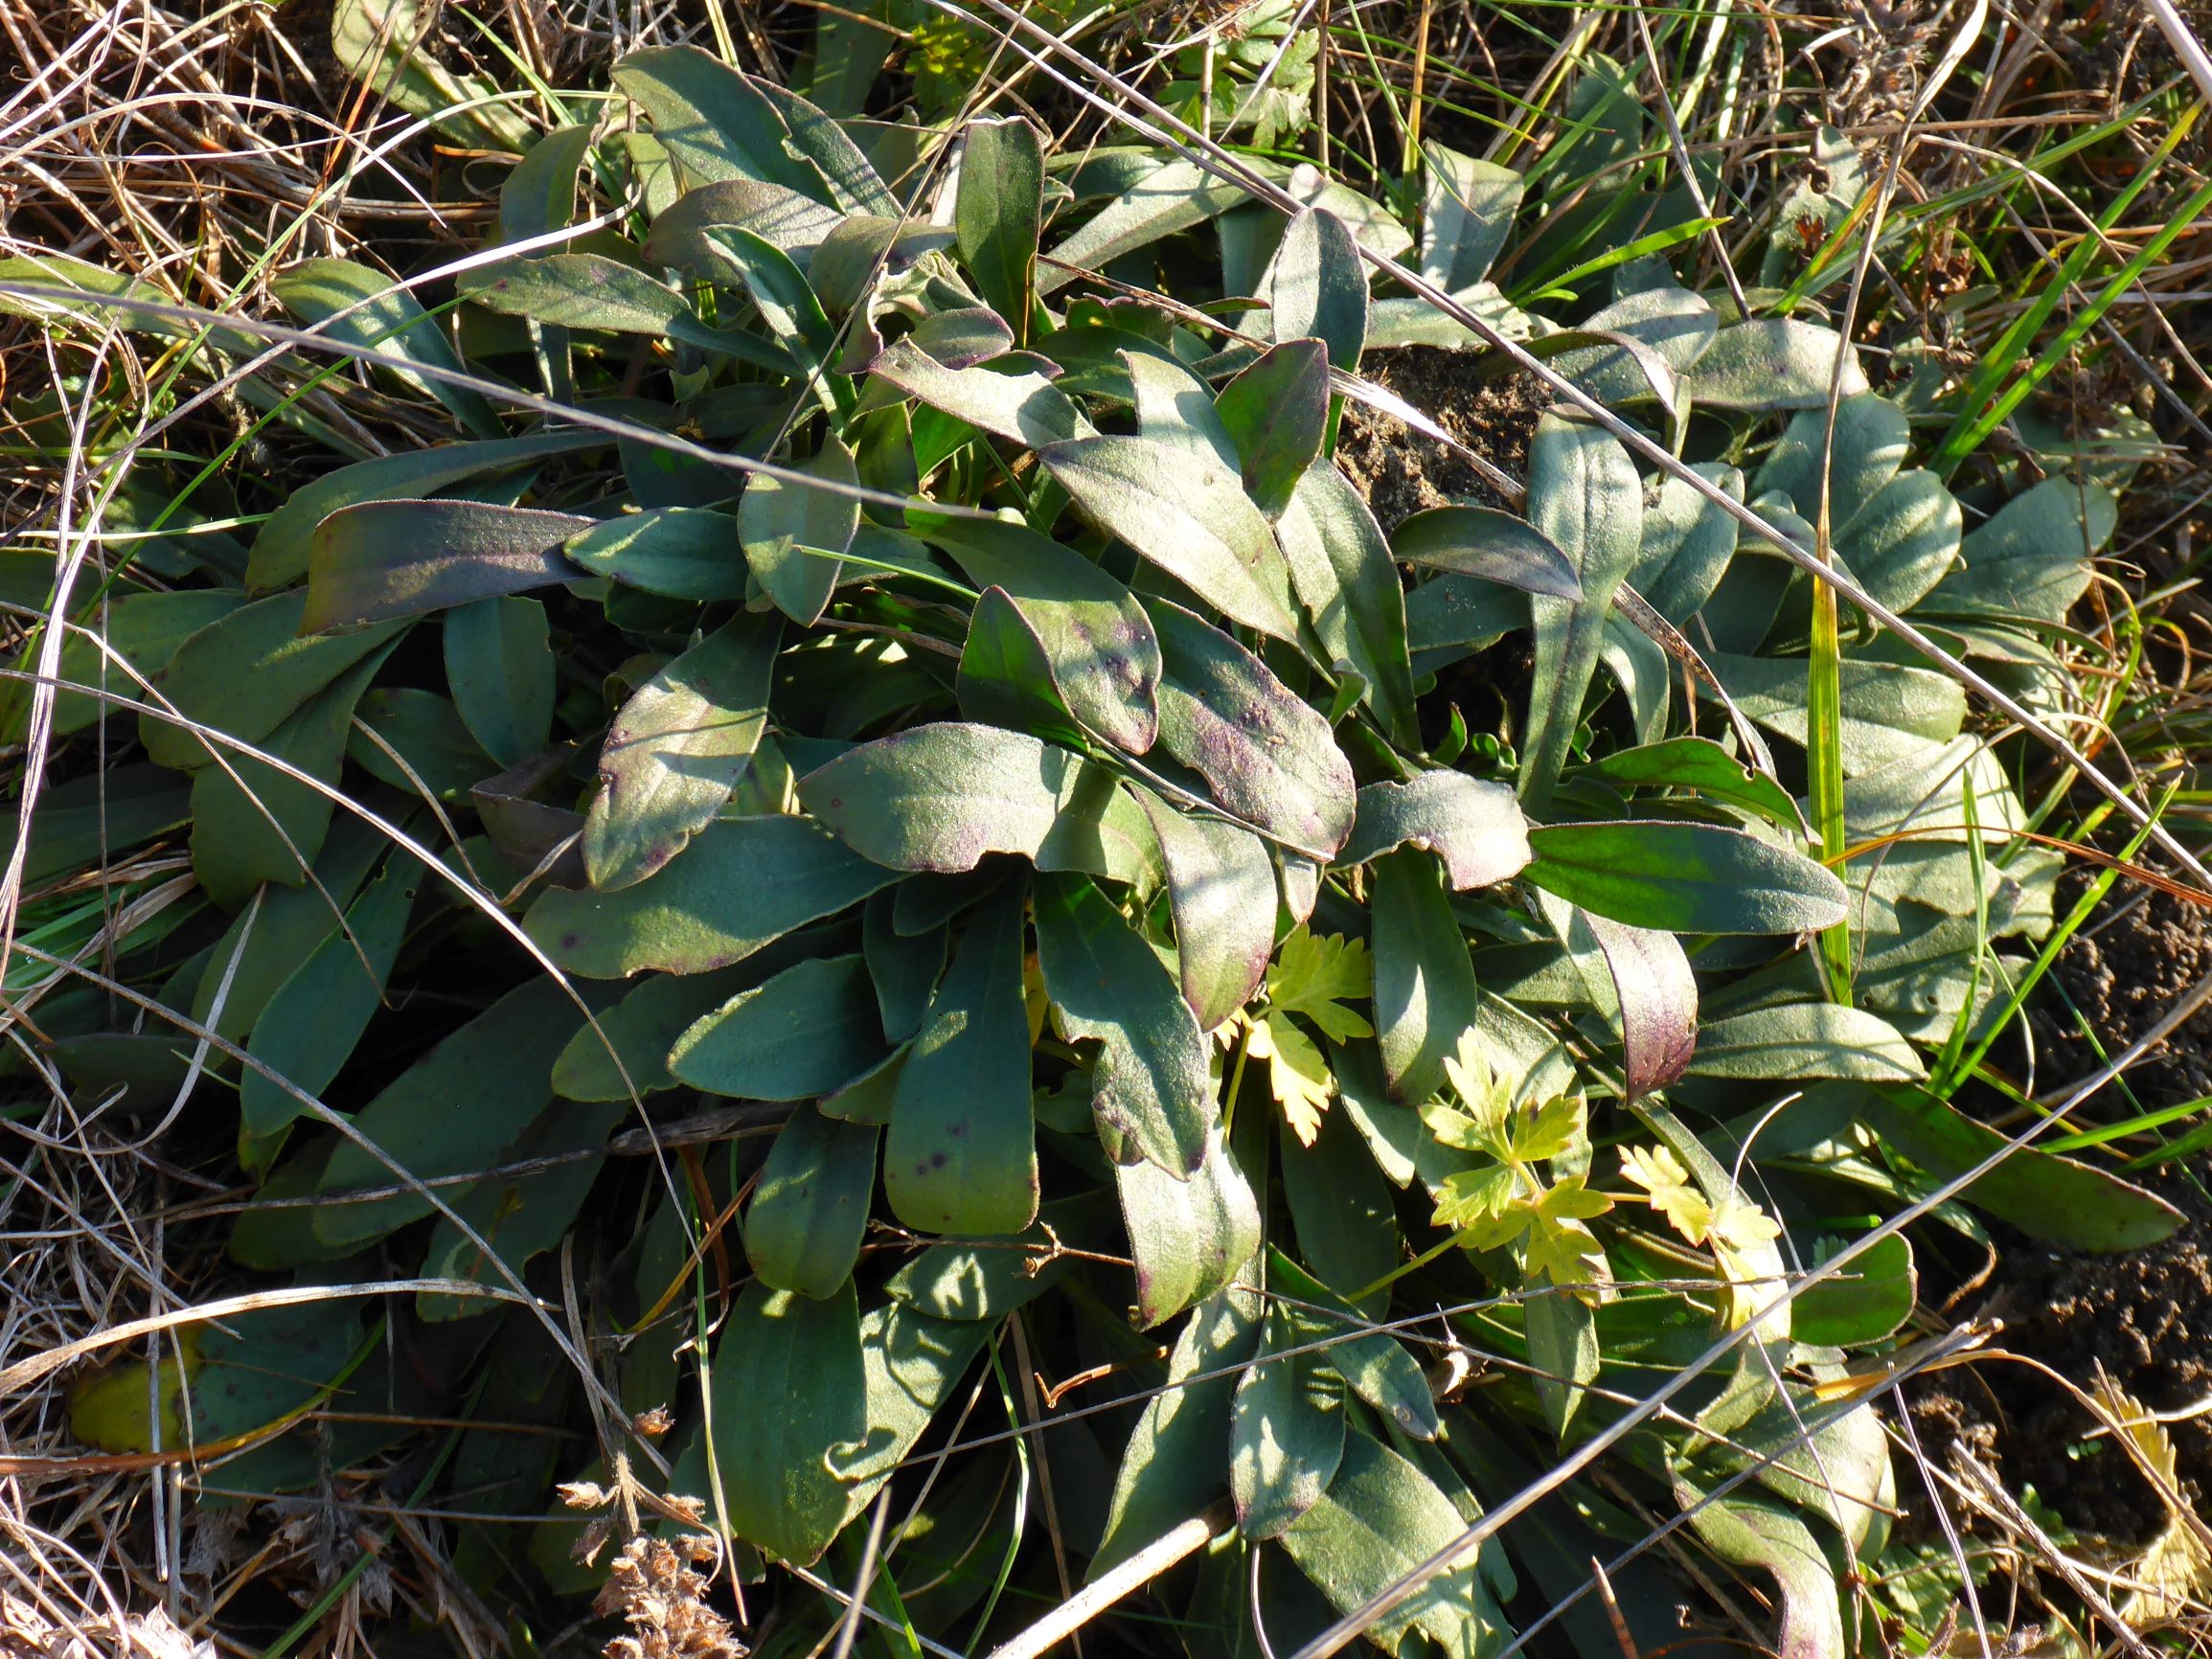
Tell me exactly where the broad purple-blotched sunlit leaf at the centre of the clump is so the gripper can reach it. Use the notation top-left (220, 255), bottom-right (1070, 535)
top-left (1144, 598), bottom-right (1356, 858)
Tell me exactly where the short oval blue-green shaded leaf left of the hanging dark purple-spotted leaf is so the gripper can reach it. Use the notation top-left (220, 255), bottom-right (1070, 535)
top-left (668, 956), bottom-right (887, 1100)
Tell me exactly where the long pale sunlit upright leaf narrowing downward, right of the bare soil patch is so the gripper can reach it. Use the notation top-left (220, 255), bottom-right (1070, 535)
top-left (1519, 414), bottom-right (1644, 812)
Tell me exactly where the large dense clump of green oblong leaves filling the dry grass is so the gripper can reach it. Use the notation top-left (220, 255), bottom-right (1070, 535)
top-left (0, 9), bottom-right (2185, 1659)
